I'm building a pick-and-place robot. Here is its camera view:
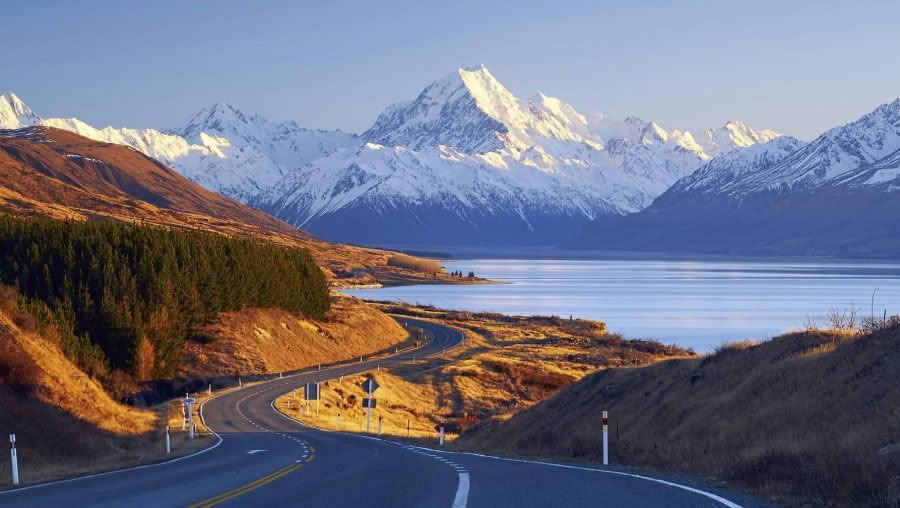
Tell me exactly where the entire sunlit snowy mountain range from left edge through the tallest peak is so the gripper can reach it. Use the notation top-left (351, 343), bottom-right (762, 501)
top-left (0, 66), bottom-right (778, 245)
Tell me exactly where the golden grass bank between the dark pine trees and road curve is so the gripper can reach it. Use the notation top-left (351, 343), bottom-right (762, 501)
top-left (179, 294), bottom-right (407, 377)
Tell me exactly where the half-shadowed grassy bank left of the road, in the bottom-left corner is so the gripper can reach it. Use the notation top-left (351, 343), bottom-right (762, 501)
top-left (0, 302), bottom-right (208, 488)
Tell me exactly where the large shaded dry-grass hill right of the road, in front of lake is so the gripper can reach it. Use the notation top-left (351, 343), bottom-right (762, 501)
top-left (457, 324), bottom-right (900, 506)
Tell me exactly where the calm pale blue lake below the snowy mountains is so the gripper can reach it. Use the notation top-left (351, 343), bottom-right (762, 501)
top-left (346, 259), bottom-right (900, 352)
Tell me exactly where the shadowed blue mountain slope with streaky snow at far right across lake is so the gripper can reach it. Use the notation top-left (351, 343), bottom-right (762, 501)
top-left (572, 99), bottom-right (900, 256)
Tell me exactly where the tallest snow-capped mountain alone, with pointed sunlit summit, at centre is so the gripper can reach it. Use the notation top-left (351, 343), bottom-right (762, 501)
top-left (251, 66), bottom-right (776, 244)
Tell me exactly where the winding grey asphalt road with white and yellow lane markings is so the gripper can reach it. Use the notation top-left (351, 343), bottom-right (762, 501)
top-left (0, 319), bottom-right (759, 508)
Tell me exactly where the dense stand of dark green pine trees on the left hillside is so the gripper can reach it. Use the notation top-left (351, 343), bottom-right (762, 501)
top-left (0, 215), bottom-right (329, 379)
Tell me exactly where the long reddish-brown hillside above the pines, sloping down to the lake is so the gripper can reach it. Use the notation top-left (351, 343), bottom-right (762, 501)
top-left (0, 127), bottom-right (483, 286)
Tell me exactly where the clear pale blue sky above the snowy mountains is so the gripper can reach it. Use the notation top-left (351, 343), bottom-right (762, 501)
top-left (8, 0), bottom-right (900, 139)
